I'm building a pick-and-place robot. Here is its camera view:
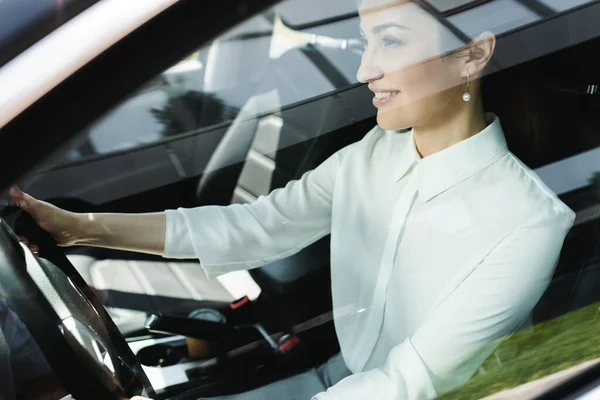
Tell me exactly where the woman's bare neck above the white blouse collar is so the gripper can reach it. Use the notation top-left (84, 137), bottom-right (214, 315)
top-left (413, 102), bottom-right (487, 157)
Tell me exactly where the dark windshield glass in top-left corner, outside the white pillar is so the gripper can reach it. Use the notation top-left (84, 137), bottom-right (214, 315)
top-left (0, 0), bottom-right (97, 66)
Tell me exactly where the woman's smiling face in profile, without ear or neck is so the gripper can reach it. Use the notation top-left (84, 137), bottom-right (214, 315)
top-left (358, 0), bottom-right (465, 130)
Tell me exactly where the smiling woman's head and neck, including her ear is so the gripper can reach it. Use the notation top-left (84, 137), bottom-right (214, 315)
top-left (358, 0), bottom-right (495, 155)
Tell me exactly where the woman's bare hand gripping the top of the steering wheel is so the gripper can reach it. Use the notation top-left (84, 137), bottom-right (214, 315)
top-left (9, 187), bottom-right (81, 246)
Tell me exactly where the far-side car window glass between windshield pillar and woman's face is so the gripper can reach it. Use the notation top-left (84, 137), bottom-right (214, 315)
top-left (56, 8), bottom-right (361, 163)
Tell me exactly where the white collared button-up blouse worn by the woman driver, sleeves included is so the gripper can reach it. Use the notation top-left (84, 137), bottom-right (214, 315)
top-left (164, 115), bottom-right (575, 400)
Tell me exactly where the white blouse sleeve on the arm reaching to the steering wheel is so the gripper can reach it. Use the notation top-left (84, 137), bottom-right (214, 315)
top-left (163, 146), bottom-right (352, 276)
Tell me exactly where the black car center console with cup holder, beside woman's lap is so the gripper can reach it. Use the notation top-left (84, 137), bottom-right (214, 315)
top-left (123, 298), bottom-right (338, 398)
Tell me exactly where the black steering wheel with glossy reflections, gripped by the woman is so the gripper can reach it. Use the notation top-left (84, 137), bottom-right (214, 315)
top-left (0, 207), bottom-right (156, 400)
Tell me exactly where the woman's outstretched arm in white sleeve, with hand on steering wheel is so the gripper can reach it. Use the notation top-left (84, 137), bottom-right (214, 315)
top-left (10, 141), bottom-right (351, 260)
